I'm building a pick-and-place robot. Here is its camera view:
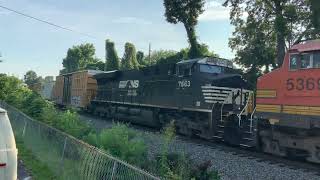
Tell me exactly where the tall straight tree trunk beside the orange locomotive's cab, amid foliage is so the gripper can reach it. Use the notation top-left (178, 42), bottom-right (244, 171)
top-left (275, 1), bottom-right (286, 66)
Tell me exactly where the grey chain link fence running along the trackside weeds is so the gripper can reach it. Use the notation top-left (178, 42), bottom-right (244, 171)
top-left (0, 101), bottom-right (160, 180)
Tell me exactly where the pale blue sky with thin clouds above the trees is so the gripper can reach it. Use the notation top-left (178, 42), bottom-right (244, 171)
top-left (0, 0), bottom-right (234, 78)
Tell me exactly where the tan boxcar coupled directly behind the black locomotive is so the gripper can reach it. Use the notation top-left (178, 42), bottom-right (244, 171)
top-left (52, 70), bottom-right (103, 109)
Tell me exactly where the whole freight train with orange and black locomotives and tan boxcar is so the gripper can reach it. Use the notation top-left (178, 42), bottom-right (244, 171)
top-left (51, 40), bottom-right (320, 163)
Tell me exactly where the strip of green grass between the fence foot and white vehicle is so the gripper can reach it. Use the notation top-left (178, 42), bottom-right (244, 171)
top-left (16, 138), bottom-right (57, 180)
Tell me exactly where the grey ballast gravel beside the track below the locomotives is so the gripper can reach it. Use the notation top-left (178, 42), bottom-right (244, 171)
top-left (82, 116), bottom-right (320, 180)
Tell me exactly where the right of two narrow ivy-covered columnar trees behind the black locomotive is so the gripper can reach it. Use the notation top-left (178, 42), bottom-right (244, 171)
top-left (121, 42), bottom-right (139, 70)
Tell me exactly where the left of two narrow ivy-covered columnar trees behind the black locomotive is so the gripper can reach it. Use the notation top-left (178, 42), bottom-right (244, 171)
top-left (105, 39), bottom-right (120, 71)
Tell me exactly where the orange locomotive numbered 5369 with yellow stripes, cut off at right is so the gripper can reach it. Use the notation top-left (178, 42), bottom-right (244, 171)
top-left (255, 40), bottom-right (320, 163)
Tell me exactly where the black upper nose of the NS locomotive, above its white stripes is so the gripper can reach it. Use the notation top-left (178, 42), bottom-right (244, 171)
top-left (212, 74), bottom-right (249, 89)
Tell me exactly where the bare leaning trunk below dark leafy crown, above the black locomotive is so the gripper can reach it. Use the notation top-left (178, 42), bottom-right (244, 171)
top-left (184, 24), bottom-right (201, 58)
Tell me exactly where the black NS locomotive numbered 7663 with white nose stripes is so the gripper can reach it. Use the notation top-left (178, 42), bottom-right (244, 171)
top-left (89, 58), bottom-right (254, 145)
